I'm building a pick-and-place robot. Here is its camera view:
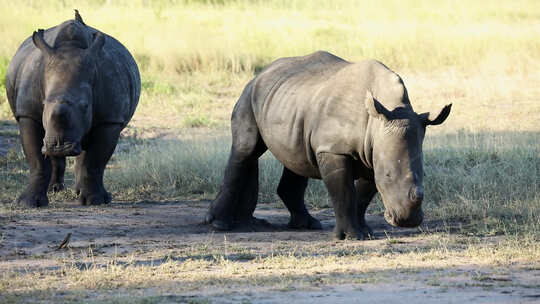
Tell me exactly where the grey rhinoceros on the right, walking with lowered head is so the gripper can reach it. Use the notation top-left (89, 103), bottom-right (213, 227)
top-left (206, 52), bottom-right (451, 239)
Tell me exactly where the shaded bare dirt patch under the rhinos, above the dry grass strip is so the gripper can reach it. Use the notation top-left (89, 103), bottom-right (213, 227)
top-left (0, 201), bottom-right (410, 269)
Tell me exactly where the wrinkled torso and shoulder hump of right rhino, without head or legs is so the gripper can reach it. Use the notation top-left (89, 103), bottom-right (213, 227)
top-left (243, 52), bottom-right (409, 177)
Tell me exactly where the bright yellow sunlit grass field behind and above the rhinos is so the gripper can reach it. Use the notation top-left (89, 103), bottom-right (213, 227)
top-left (0, 0), bottom-right (540, 130)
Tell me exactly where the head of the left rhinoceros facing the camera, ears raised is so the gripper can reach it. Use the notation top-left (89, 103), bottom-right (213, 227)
top-left (32, 30), bottom-right (105, 156)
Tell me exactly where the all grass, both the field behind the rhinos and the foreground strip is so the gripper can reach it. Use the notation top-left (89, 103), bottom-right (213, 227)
top-left (0, 0), bottom-right (540, 302)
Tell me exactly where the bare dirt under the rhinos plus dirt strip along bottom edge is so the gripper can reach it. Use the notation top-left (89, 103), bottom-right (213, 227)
top-left (0, 201), bottom-right (540, 303)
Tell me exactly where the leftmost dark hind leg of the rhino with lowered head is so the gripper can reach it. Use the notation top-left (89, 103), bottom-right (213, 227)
top-left (206, 90), bottom-right (267, 230)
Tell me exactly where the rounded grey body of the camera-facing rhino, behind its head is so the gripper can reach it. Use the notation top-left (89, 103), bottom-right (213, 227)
top-left (6, 20), bottom-right (141, 125)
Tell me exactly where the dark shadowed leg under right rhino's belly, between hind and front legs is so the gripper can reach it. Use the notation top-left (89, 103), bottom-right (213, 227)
top-left (277, 167), bottom-right (322, 229)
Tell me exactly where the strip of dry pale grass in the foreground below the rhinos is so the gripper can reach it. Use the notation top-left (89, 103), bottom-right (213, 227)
top-left (0, 235), bottom-right (540, 294)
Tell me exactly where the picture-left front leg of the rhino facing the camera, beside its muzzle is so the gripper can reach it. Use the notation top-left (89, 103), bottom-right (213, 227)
top-left (16, 117), bottom-right (51, 207)
